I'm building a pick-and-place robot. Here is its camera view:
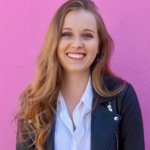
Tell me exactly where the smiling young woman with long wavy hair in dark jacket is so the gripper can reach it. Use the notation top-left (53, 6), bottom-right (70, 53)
top-left (17, 0), bottom-right (144, 150)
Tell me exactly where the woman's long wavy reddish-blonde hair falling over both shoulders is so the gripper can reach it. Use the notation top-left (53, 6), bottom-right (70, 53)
top-left (16, 0), bottom-right (124, 150)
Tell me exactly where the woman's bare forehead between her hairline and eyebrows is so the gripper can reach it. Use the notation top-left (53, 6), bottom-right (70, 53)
top-left (63, 10), bottom-right (97, 30)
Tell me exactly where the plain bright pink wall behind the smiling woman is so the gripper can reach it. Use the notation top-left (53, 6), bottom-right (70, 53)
top-left (0, 0), bottom-right (150, 150)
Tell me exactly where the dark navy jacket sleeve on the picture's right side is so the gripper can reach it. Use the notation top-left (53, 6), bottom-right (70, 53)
top-left (119, 84), bottom-right (145, 150)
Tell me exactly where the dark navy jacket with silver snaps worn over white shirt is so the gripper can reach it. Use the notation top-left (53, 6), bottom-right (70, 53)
top-left (16, 79), bottom-right (145, 150)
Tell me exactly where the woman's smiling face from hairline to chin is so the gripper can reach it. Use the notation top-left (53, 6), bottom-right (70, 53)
top-left (57, 10), bottom-right (99, 73)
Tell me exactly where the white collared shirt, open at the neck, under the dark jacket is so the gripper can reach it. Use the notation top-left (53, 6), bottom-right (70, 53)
top-left (54, 77), bottom-right (93, 150)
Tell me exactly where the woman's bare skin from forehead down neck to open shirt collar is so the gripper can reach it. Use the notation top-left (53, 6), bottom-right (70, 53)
top-left (57, 10), bottom-right (99, 125)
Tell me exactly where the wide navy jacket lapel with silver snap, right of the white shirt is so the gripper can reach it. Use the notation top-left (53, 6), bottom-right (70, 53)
top-left (91, 96), bottom-right (121, 150)
